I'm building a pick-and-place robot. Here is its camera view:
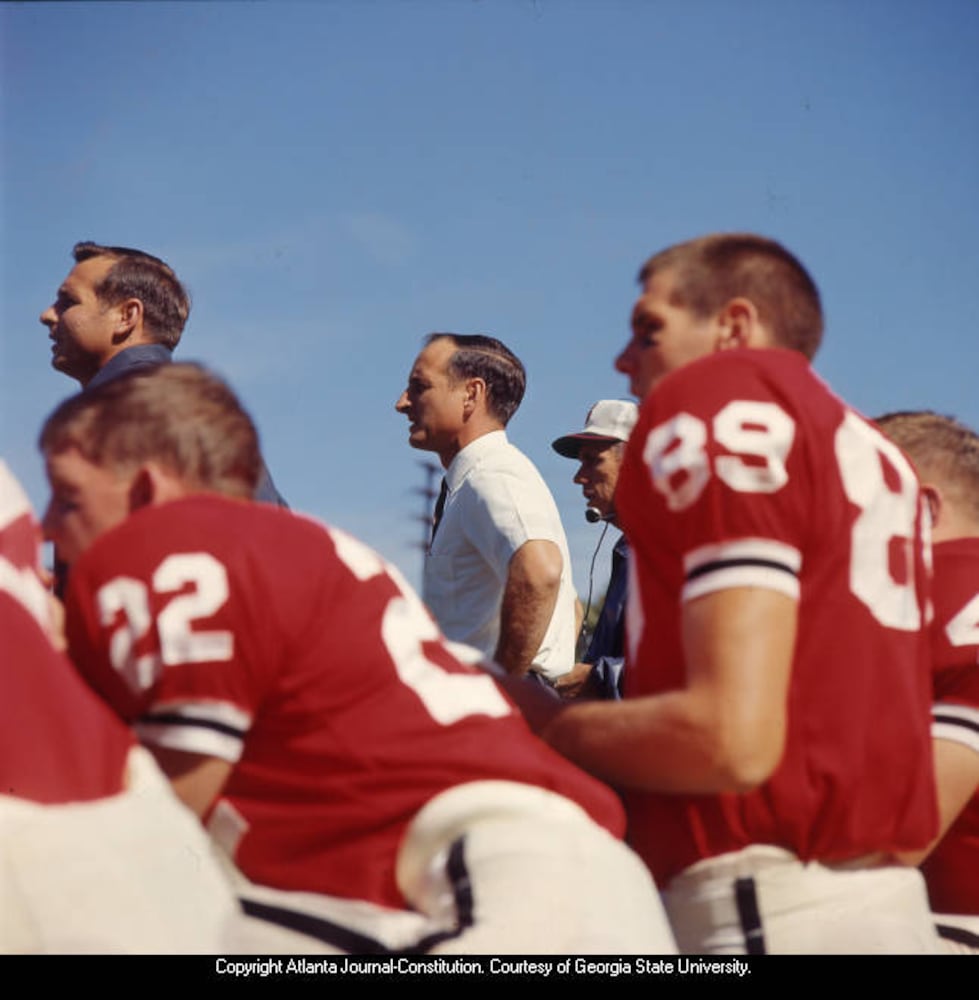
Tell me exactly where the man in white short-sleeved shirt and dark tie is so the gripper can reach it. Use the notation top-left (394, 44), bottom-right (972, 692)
top-left (395, 333), bottom-right (576, 682)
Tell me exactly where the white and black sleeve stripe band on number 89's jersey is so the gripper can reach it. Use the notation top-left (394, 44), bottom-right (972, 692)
top-left (682, 538), bottom-right (802, 601)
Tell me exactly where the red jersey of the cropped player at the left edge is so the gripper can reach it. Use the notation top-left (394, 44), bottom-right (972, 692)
top-left (0, 462), bottom-right (135, 804)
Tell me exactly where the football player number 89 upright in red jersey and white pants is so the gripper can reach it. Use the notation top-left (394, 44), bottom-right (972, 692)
top-left (542, 234), bottom-right (938, 953)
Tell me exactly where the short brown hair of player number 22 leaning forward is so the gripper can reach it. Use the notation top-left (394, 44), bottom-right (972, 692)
top-left (38, 364), bottom-right (262, 498)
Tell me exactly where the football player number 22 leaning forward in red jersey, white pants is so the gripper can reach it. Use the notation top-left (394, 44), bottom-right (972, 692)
top-left (41, 365), bottom-right (675, 953)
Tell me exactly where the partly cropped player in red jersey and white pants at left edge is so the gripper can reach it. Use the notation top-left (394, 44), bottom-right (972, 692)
top-left (0, 462), bottom-right (239, 954)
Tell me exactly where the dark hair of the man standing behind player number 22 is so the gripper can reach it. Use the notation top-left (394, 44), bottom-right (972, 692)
top-left (71, 241), bottom-right (190, 350)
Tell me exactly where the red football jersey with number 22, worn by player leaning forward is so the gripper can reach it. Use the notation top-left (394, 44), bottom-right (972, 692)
top-left (67, 496), bottom-right (624, 906)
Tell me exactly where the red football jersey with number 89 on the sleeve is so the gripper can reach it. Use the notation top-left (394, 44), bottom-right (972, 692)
top-left (616, 349), bottom-right (937, 885)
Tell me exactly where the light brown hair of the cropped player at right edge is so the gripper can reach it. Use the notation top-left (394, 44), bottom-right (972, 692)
top-left (876, 410), bottom-right (979, 527)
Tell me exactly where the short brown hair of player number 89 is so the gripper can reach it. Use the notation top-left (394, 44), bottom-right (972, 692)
top-left (639, 233), bottom-right (823, 360)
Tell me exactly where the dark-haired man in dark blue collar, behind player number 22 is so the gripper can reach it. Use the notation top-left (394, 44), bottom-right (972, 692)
top-left (40, 241), bottom-right (286, 508)
